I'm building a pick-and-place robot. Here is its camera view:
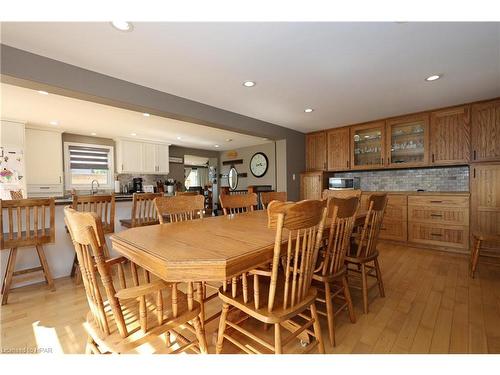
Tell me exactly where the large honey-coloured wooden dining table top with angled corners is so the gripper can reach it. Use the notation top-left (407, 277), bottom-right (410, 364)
top-left (111, 210), bottom-right (366, 282)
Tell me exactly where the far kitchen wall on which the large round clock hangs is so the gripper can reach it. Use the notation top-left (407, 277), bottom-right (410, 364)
top-left (219, 142), bottom-right (276, 190)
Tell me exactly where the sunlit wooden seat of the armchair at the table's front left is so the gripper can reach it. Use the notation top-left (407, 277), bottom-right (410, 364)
top-left (83, 290), bottom-right (200, 354)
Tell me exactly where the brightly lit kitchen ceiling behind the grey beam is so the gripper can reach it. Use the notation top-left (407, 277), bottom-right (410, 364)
top-left (0, 83), bottom-right (267, 151)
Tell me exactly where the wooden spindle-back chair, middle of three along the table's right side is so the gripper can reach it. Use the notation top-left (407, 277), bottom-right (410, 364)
top-left (313, 197), bottom-right (359, 346)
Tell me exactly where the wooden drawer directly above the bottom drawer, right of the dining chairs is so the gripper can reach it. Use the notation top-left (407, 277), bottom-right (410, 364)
top-left (408, 206), bottom-right (469, 226)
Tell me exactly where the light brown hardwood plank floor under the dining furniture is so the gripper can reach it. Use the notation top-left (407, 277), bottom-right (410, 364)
top-left (0, 243), bottom-right (500, 353)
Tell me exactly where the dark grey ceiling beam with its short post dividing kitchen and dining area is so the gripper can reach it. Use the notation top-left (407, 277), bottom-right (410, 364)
top-left (0, 44), bottom-right (305, 199)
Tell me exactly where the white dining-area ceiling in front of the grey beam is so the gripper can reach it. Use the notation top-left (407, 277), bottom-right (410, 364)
top-left (2, 22), bottom-right (500, 132)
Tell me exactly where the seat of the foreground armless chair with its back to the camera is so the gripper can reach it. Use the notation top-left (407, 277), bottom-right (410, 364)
top-left (219, 277), bottom-right (317, 324)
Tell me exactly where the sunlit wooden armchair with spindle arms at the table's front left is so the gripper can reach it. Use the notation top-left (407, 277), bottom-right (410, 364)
top-left (64, 207), bottom-right (207, 354)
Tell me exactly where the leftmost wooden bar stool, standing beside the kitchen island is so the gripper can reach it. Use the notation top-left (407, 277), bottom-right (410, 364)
top-left (0, 198), bottom-right (55, 305)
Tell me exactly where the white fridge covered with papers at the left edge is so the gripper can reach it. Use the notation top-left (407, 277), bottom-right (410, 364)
top-left (0, 146), bottom-right (26, 199)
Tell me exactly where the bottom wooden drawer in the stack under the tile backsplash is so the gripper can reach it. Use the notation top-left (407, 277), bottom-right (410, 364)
top-left (408, 223), bottom-right (469, 249)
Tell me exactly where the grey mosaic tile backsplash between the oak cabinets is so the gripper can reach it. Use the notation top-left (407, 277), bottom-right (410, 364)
top-left (334, 166), bottom-right (469, 191)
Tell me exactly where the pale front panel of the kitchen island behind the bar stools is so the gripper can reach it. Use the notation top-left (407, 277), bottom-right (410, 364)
top-left (0, 202), bottom-right (132, 287)
